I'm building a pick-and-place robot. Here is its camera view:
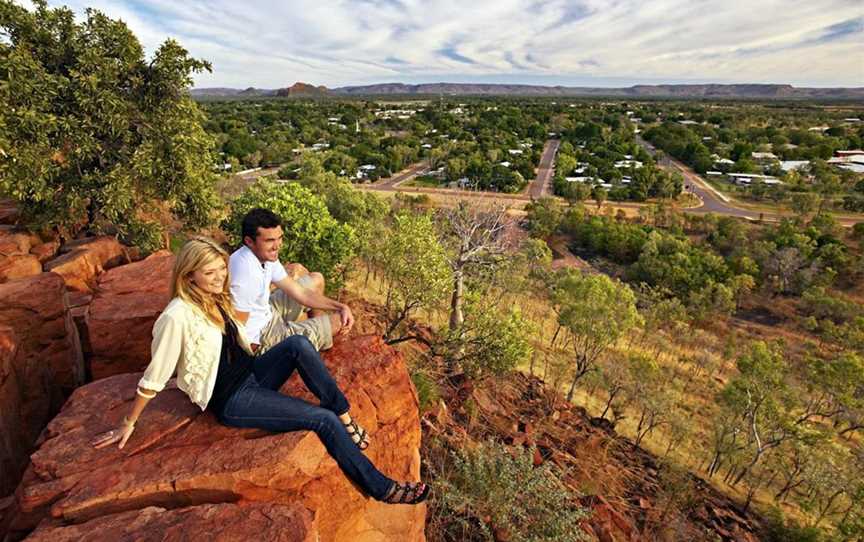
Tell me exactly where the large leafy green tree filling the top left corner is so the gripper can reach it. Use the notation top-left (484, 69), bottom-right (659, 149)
top-left (0, 0), bottom-right (216, 250)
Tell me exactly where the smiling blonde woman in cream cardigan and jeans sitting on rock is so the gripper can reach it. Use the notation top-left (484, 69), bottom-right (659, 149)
top-left (93, 239), bottom-right (429, 504)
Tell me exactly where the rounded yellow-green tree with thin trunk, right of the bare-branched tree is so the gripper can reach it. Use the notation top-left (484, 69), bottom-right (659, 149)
top-left (553, 269), bottom-right (642, 401)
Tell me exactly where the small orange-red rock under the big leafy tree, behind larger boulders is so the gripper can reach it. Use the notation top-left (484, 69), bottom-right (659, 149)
top-left (45, 236), bottom-right (128, 292)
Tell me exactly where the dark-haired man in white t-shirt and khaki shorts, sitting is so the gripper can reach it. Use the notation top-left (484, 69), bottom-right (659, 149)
top-left (228, 208), bottom-right (354, 354)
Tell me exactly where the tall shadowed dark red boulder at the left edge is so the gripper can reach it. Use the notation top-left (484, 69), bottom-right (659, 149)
top-left (0, 273), bottom-right (84, 504)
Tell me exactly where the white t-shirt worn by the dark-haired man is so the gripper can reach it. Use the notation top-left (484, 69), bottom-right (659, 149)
top-left (228, 245), bottom-right (288, 343)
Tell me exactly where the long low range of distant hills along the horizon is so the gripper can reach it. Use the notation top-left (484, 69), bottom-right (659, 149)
top-left (192, 82), bottom-right (864, 100)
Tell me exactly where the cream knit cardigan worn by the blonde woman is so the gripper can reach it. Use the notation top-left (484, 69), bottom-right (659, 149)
top-left (138, 297), bottom-right (252, 410)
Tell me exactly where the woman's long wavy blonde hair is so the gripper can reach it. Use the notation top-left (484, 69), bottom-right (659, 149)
top-left (171, 237), bottom-right (237, 327)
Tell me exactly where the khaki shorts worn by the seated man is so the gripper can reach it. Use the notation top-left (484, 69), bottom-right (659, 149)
top-left (256, 275), bottom-right (333, 355)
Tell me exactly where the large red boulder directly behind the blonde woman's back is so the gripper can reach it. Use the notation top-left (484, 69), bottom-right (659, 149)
top-left (87, 250), bottom-right (174, 379)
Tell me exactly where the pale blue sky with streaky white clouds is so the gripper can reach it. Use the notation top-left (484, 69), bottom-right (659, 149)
top-left (19, 0), bottom-right (864, 88)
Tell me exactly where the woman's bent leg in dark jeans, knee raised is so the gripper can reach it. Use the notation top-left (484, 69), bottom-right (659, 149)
top-left (252, 335), bottom-right (350, 415)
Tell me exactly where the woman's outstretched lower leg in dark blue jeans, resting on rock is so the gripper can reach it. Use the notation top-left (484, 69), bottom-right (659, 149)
top-left (220, 382), bottom-right (393, 500)
